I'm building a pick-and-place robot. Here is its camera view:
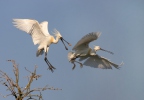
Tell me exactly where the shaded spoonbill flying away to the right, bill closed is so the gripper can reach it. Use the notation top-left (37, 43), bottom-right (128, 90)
top-left (68, 32), bottom-right (122, 69)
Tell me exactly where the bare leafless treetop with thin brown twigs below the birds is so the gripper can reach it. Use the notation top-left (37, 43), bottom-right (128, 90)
top-left (0, 60), bottom-right (62, 100)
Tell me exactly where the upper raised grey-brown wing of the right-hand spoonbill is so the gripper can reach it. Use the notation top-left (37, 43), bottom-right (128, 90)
top-left (72, 32), bottom-right (101, 50)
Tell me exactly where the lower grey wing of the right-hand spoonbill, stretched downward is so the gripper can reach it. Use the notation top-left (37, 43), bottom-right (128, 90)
top-left (83, 55), bottom-right (120, 69)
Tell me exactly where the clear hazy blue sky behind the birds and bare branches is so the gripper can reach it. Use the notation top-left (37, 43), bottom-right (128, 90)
top-left (0, 0), bottom-right (144, 100)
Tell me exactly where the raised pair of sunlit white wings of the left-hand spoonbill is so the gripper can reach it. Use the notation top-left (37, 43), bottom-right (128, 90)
top-left (13, 19), bottom-right (49, 45)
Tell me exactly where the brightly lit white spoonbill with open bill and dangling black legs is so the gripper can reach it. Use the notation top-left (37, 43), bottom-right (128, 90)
top-left (13, 19), bottom-right (71, 72)
